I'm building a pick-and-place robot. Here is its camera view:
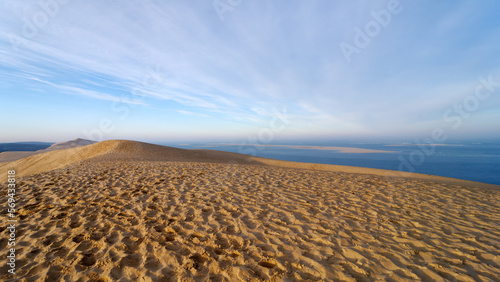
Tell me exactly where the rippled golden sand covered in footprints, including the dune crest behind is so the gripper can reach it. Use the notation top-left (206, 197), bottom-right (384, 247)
top-left (0, 141), bottom-right (500, 281)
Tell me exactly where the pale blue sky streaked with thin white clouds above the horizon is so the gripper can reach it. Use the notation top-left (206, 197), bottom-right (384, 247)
top-left (0, 0), bottom-right (500, 143)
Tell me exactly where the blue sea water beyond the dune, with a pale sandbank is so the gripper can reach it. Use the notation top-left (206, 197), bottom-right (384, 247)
top-left (171, 142), bottom-right (500, 185)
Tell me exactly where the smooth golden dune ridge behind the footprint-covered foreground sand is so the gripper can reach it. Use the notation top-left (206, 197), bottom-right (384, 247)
top-left (0, 139), bottom-right (500, 189)
